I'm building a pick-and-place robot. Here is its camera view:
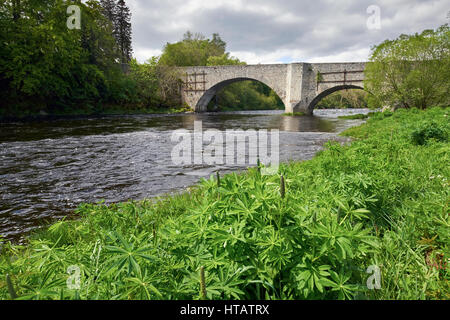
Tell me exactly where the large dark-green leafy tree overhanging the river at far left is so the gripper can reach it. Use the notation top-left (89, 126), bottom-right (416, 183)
top-left (0, 0), bottom-right (130, 115)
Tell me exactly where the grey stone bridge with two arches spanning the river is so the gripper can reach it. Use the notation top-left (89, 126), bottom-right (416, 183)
top-left (182, 62), bottom-right (366, 114)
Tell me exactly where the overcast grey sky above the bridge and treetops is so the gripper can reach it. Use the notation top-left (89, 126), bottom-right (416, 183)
top-left (127, 0), bottom-right (450, 64)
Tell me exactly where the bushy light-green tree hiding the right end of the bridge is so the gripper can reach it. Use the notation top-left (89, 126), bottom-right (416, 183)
top-left (365, 24), bottom-right (450, 109)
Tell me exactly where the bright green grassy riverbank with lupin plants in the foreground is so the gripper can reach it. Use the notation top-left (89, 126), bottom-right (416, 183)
top-left (0, 108), bottom-right (450, 299)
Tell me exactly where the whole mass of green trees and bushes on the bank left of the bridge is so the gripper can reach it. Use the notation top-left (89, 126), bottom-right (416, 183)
top-left (0, 0), bottom-right (188, 117)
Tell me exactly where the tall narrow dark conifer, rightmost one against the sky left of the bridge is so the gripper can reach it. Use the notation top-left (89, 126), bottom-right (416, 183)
top-left (115, 0), bottom-right (133, 63)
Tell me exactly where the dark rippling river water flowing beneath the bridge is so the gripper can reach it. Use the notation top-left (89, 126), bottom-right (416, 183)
top-left (0, 109), bottom-right (368, 240)
